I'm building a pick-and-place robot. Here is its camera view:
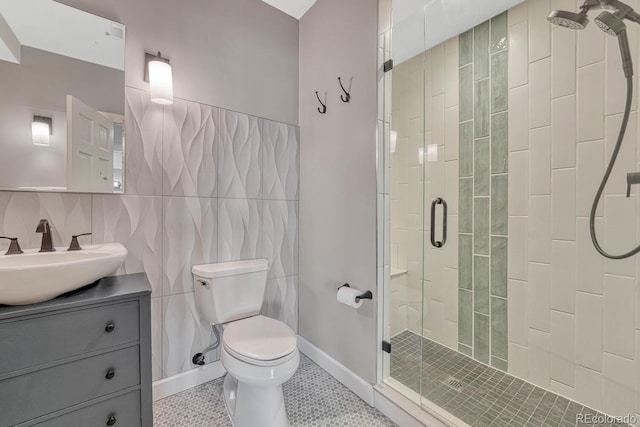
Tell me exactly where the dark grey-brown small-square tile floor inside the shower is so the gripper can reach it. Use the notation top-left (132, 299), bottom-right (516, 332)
top-left (391, 331), bottom-right (624, 427)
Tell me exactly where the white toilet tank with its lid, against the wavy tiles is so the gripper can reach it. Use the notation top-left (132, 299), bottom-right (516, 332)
top-left (191, 259), bottom-right (269, 325)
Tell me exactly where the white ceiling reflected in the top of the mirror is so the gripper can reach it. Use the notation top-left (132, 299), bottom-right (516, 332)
top-left (0, 0), bottom-right (125, 70)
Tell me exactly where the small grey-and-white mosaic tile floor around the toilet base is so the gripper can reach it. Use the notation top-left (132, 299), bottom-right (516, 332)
top-left (153, 354), bottom-right (395, 427)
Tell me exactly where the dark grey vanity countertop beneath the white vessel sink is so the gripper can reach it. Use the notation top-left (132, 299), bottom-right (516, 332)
top-left (0, 273), bottom-right (151, 320)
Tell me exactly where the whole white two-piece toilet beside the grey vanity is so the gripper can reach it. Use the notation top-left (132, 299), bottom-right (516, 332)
top-left (192, 259), bottom-right (300, 427)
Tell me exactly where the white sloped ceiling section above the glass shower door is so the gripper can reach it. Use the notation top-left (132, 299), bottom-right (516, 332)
top-left (392, 0), bottom-right (524, 64)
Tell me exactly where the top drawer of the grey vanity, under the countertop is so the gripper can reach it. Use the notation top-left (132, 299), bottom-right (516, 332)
top-left (0, 301), bottom-right (140, 376)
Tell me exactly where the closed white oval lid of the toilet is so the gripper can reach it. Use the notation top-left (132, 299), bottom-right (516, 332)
top-left (222, 316), bottom-right (296, 361)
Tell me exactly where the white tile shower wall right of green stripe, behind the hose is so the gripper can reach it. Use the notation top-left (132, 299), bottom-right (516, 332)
top-left (508, 0), bottom-right (640, 415)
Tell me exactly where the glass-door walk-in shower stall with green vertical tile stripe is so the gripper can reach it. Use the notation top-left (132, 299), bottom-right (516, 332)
top-left (378, 0), bottom-right (640, 426)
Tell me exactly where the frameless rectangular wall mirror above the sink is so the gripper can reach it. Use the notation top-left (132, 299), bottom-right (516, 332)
top-left (0, 0), bottom-right (125, 193)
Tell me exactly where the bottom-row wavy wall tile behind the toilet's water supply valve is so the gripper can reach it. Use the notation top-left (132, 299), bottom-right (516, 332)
top-left (162, 292), bottom-right (220, 378)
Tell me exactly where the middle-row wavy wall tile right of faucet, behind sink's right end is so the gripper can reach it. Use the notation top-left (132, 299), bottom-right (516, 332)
top-left (92, 194), bottom-right (162, 298)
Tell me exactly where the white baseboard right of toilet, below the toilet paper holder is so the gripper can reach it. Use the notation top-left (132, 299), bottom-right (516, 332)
top-left (298, 335), bottom-right (375, 406)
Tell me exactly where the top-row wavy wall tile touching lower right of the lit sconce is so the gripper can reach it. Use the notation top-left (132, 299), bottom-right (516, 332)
top-left (162, 99), bottom-right (219, 197)
